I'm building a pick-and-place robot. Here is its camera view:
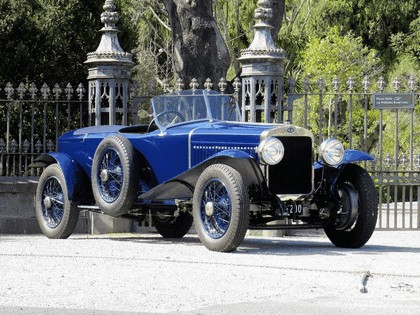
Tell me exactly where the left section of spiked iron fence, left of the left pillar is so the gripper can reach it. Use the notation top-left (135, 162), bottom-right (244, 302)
top-left (0, 83), bottom-right (88, 176)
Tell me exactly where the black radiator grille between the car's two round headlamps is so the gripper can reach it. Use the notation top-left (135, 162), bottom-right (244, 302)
top-left (268, 137), bottom-right (313, 195)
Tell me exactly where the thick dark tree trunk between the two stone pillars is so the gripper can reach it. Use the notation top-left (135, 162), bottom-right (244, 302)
top-left (163, 0), bottom-right (230, 87)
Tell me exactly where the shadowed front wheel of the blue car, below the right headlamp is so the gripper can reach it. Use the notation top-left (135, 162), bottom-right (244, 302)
top-left (325, 164), bottom-right (378, 248)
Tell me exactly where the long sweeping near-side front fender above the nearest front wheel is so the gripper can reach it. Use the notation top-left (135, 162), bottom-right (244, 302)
top-left (139, 150), bottom-right (266, 200)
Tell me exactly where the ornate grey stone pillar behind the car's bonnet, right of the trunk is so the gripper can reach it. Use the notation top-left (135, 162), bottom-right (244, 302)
top-left (239, 0), bottom-right (285, 123)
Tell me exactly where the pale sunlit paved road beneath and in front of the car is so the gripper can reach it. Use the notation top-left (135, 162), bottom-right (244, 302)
top-left (0, 231), bottom-right (420, 315)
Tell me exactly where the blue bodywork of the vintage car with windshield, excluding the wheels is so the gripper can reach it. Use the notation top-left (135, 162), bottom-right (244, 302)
top-left (33, 90), bottom-right (378, 252)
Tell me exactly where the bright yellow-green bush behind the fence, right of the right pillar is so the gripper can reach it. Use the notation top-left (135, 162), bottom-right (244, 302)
top-left (288, 27), bottom-right (380, 150)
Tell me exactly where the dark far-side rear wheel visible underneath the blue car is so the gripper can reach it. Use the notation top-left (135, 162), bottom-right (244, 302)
top-left (152, 211), bottom-right (193, 238)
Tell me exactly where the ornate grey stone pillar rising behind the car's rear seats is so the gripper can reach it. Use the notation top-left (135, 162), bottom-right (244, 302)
top-left (85, 0), bottom-right (134, 126)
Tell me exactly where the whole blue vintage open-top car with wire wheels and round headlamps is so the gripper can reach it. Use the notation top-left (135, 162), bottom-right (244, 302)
top-left (33, 90), bottom-right (378, 252)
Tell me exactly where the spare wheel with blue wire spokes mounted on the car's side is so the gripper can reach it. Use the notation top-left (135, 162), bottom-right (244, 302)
top-left (92, 135), bottom-right (138, 217)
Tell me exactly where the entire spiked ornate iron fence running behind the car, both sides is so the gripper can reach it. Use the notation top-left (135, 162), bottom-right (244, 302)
top-left (0, 77), bottom-right (420, 229)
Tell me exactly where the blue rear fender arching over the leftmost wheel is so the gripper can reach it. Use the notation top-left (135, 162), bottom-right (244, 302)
top-left (30, 152), bottom-right (90, 200)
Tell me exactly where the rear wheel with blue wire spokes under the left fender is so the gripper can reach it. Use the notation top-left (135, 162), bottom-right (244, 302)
top-left (35, 164), bottom-right (79, 239)
